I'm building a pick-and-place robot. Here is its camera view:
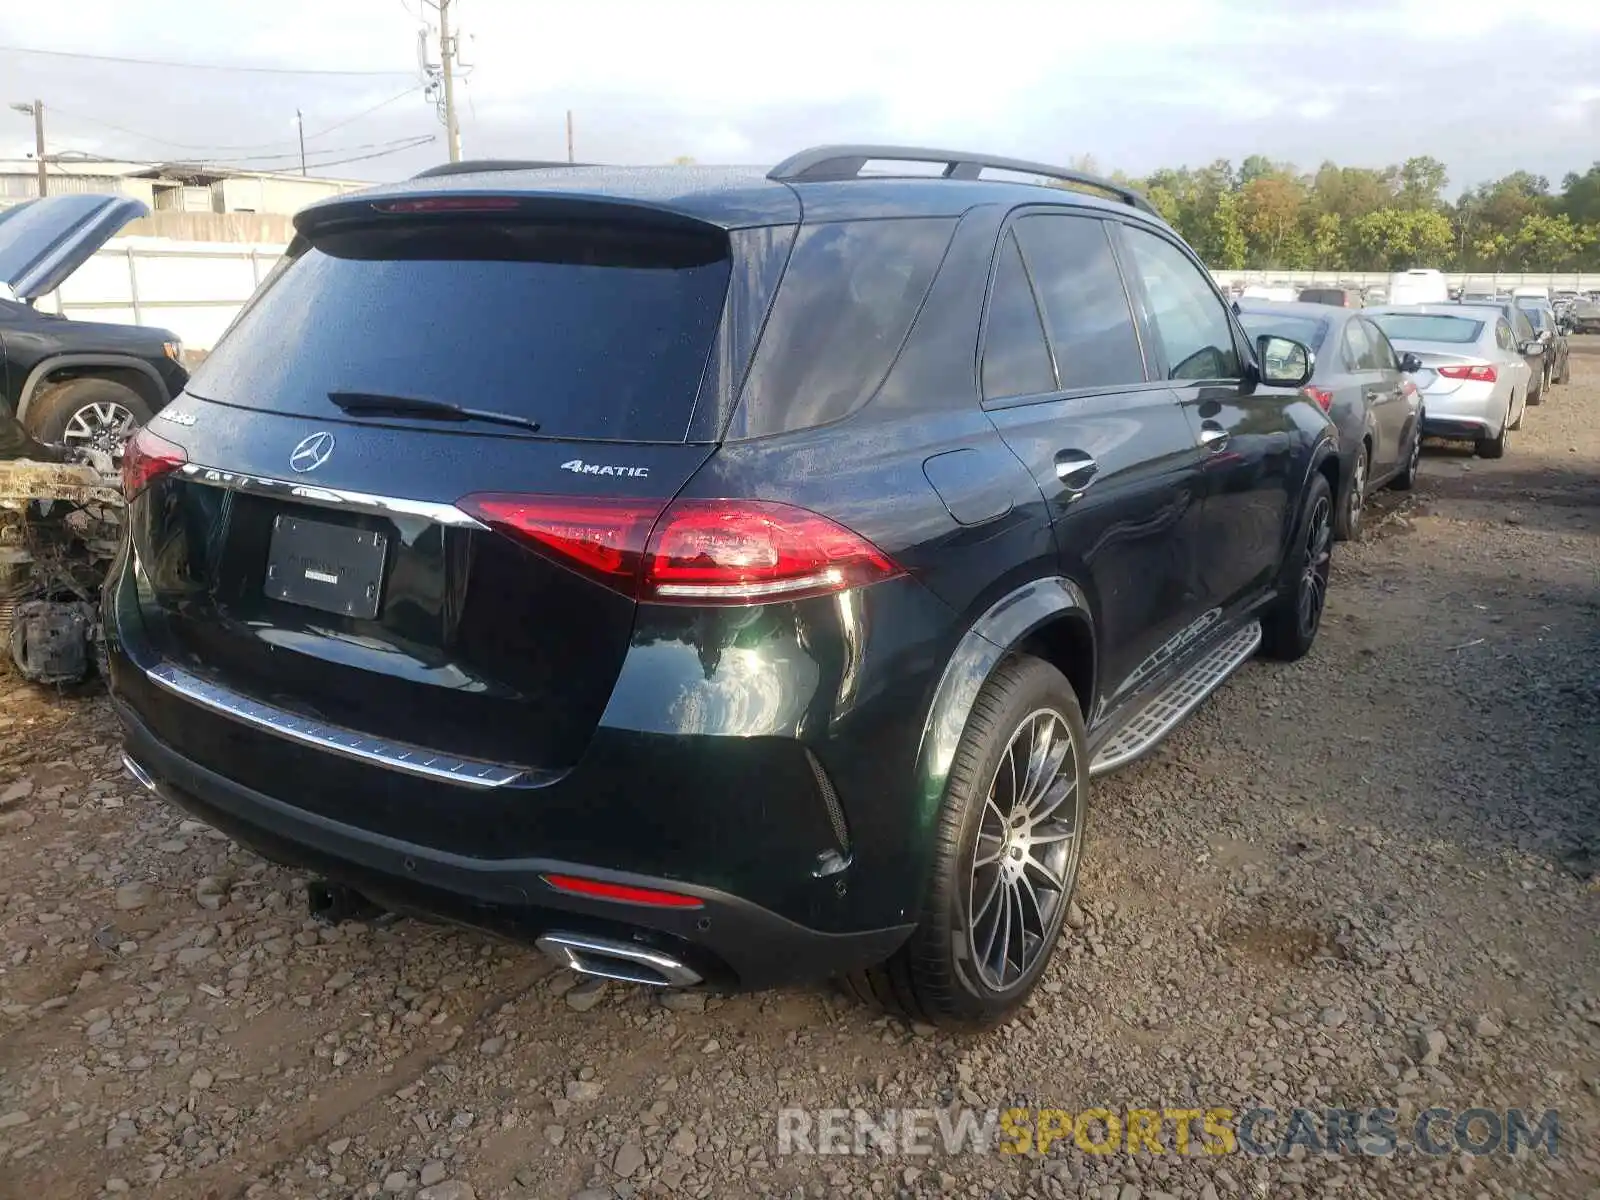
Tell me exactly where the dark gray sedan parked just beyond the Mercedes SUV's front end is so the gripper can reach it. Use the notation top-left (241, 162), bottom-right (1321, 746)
top-left (1238, 301), bottom-right (1422, 538)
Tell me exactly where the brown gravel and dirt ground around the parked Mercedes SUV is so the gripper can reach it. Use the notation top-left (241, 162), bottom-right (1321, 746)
top-left (0, 339), bottom-right (1600, 1200)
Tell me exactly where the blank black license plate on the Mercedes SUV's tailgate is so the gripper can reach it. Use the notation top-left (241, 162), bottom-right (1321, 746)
top-left (261, 517), bottom-right (389, 619)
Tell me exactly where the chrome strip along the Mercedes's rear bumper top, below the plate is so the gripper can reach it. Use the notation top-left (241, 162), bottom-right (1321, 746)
top-left (144, 662), bottom-right (523, 787)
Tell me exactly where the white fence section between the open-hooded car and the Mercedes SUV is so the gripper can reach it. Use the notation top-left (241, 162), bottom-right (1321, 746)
top-left (38, 237), bottom-right (285, 350)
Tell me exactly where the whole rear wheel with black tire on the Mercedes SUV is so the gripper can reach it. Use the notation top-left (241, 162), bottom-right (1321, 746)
top-left (842, 654), bottom-right (1090, 1029)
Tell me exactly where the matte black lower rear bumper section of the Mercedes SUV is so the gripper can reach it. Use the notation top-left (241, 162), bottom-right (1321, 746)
top-left (114, 698), bottom-right (910, 989)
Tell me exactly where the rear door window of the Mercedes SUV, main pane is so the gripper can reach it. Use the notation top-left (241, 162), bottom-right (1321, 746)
top-left (1016, 213), bottom-right (1144, 389)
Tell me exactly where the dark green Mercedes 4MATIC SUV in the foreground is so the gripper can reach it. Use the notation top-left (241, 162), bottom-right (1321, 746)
top-left (106, 147), bottom-right (1338, 1024)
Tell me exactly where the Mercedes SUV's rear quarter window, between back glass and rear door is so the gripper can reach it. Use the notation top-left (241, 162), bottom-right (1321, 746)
top-left (730, 218), bottom-right (955, 437)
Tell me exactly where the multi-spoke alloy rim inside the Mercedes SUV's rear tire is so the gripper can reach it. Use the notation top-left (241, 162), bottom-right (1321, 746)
top-left (966, 709), bottom-right (1083, 992)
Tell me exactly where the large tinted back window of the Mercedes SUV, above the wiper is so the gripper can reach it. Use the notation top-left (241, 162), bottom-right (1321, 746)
top-left (189, 219), bottom-right (730, 442)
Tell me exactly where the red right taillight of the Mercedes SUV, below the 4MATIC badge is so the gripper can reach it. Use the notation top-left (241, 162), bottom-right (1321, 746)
top-left (458, 493), bottom-right (901, 605)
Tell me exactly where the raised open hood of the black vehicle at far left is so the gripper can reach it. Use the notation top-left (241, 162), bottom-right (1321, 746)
top-left (0, 195), bottom-right (150, 301)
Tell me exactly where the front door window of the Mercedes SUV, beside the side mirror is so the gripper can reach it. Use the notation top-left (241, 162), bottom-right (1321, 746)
top-left (1123, 226), bottom-right (1240, 379)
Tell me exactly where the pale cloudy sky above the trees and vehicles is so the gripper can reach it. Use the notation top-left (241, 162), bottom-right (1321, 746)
top-left (0, 0), bottom-right (1600, 197)
